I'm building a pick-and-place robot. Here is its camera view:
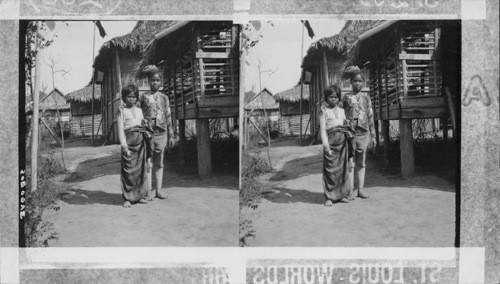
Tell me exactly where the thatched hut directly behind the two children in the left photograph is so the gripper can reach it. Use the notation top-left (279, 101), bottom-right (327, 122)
top-left (93, 21), bottom-right (176, 143)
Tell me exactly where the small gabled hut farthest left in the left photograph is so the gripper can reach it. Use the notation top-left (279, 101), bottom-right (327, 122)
top-left (39, 88), bottom-right (70, 136)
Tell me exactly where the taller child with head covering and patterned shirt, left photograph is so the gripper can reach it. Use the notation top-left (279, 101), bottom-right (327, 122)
top-left (140, 65), bottom-right (174, 199)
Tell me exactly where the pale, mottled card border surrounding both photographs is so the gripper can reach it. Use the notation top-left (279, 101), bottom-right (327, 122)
top-left (0, 0), bottom-right (500, 284)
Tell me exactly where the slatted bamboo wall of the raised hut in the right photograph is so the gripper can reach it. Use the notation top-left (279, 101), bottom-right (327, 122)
top-left (369, 21), bottom-right (448, 119)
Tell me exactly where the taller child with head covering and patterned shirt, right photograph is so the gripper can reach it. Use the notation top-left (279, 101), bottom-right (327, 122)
top-left (342, 66), bottom-right (375, 198)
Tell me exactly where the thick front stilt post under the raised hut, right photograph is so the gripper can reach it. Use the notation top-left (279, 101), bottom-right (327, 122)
top-left (399, 118), bottom-right (415, 177)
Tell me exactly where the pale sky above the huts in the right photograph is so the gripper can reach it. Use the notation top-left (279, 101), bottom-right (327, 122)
top-left (245, 20), bottom-right (345, 93)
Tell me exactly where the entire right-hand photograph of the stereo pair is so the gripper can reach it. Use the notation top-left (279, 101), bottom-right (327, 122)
top-left (240, 20), bottom-right (461, 247)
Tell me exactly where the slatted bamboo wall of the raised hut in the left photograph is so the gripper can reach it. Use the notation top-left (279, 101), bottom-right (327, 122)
top-left (163, 22), bottom-right (239, 119)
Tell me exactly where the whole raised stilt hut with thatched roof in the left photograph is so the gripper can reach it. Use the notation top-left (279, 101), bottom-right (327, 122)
top-left (136, 21), bottom-right (240, 176)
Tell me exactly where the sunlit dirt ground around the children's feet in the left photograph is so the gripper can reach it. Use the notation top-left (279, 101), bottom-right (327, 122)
top-left (46, 142), bottom-right (238, 247)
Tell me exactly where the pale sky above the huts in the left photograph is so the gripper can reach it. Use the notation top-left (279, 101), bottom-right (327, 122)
top-left (41, 21), bottom-right (136, 95)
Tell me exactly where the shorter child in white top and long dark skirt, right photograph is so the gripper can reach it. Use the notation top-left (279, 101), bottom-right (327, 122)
top-left (319, 85), bottom-right (354, 206)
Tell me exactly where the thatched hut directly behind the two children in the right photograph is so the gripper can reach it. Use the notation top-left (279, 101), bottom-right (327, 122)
top-left (302, 20), bottom-right (384, 138)
